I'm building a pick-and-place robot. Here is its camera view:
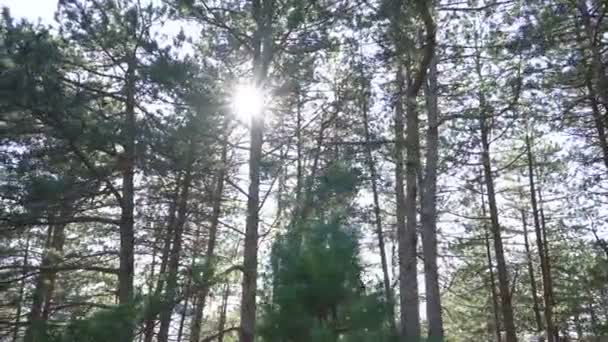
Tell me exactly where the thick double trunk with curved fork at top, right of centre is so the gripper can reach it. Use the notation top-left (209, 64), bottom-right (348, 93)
top-left (391, 0), bottom-right (435, 341)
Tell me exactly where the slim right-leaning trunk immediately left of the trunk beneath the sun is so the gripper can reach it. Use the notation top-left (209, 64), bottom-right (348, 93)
top-left (190, 118), bottom-right (228, 342)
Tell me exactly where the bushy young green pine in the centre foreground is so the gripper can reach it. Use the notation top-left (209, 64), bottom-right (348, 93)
top-left (260, 165), bottom-right (390, 341)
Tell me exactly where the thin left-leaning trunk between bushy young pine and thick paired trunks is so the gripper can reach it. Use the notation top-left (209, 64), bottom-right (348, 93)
top-left (360, 81), bottom-right (397, 333)
